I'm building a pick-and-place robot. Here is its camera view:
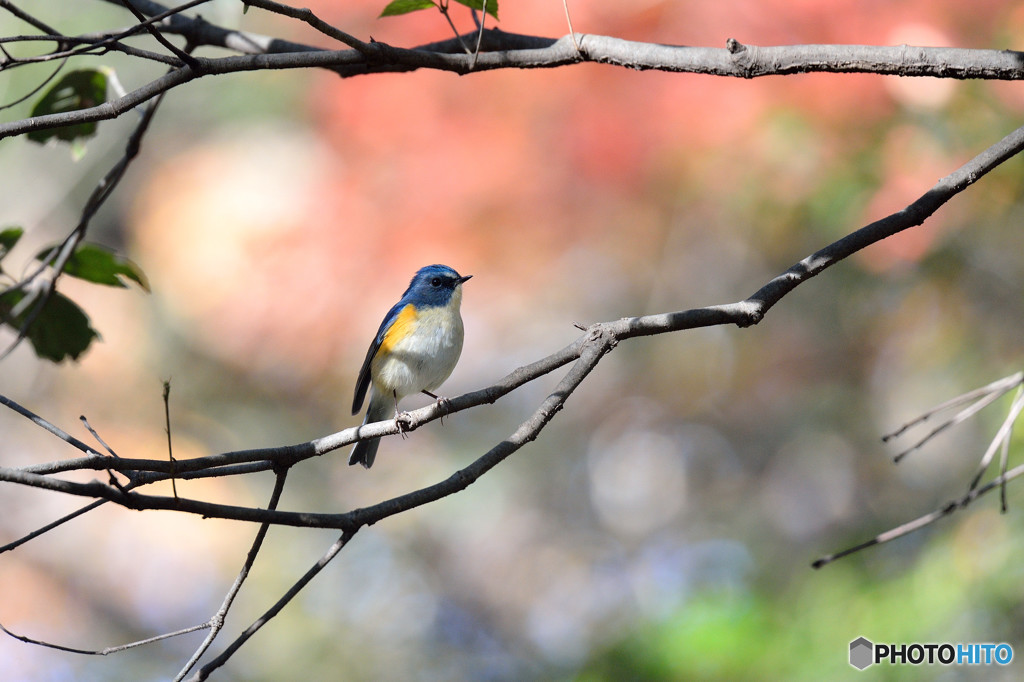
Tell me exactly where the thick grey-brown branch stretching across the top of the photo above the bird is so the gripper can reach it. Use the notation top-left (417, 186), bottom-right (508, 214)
top-left (0, 28), bottom-right (1024, 139)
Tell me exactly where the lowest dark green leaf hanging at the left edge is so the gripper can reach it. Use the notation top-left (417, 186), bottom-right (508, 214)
top-left (0, 291), bottom-right (99, 363)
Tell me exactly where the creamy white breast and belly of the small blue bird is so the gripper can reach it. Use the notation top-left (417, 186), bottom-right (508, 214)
top-left (373, 306), bottom-right (463, 400)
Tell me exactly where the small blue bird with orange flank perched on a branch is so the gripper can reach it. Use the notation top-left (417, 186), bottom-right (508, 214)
top-left (348, 265), bottom-right (473, 469)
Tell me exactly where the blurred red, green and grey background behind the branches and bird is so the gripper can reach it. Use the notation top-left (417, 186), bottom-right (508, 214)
top-left (0, 0), bottom-right (1024, 681)
